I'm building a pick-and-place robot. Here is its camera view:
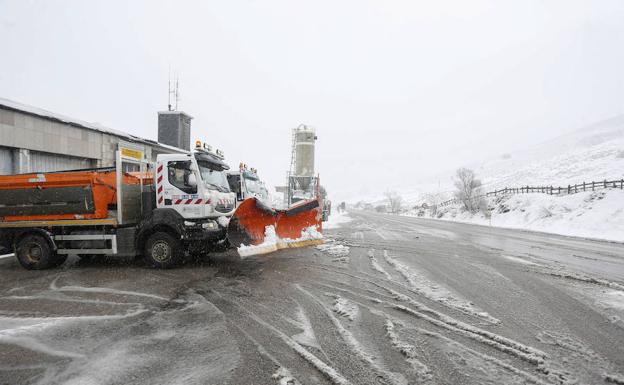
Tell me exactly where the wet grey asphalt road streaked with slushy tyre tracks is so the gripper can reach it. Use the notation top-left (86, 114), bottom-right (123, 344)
top-left (0, 212), bottom-right (624, 384)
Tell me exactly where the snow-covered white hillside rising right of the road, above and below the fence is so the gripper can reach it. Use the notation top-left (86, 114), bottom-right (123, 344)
top-left (356, 115), bottom-right (624, 242)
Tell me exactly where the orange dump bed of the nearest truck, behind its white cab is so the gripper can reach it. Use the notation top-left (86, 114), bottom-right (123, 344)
top-left (0, 169), bottom-right (152, 224)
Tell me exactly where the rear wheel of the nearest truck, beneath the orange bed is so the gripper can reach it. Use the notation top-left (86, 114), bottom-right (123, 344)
top-left (15, 234), bottom-right (61, 270)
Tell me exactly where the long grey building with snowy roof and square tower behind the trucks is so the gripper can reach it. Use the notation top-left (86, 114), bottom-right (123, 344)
top-left (0, 98), bottom-right (192, 175)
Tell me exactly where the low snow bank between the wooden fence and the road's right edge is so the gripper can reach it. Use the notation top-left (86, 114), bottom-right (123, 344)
top-left (438, 189), bottom-right (624, 241)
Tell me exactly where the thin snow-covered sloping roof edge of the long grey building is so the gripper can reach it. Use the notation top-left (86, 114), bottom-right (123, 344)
top-left (0, 97), bottom-right (188, 152)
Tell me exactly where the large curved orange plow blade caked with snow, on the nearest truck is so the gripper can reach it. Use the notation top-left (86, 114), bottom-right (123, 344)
top-left (227, 198), bottom-right (323, 255)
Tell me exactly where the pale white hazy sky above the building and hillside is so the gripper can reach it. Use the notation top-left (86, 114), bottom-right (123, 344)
top-left (0, 0), bottom-right (624, 199)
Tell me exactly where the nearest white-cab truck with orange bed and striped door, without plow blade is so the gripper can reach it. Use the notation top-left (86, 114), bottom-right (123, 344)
top-left (0, 146), bottom-right (236, 269)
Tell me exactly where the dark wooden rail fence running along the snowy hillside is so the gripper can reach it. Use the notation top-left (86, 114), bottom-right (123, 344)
top-left (439, 179), bottom-right (624, 207)
